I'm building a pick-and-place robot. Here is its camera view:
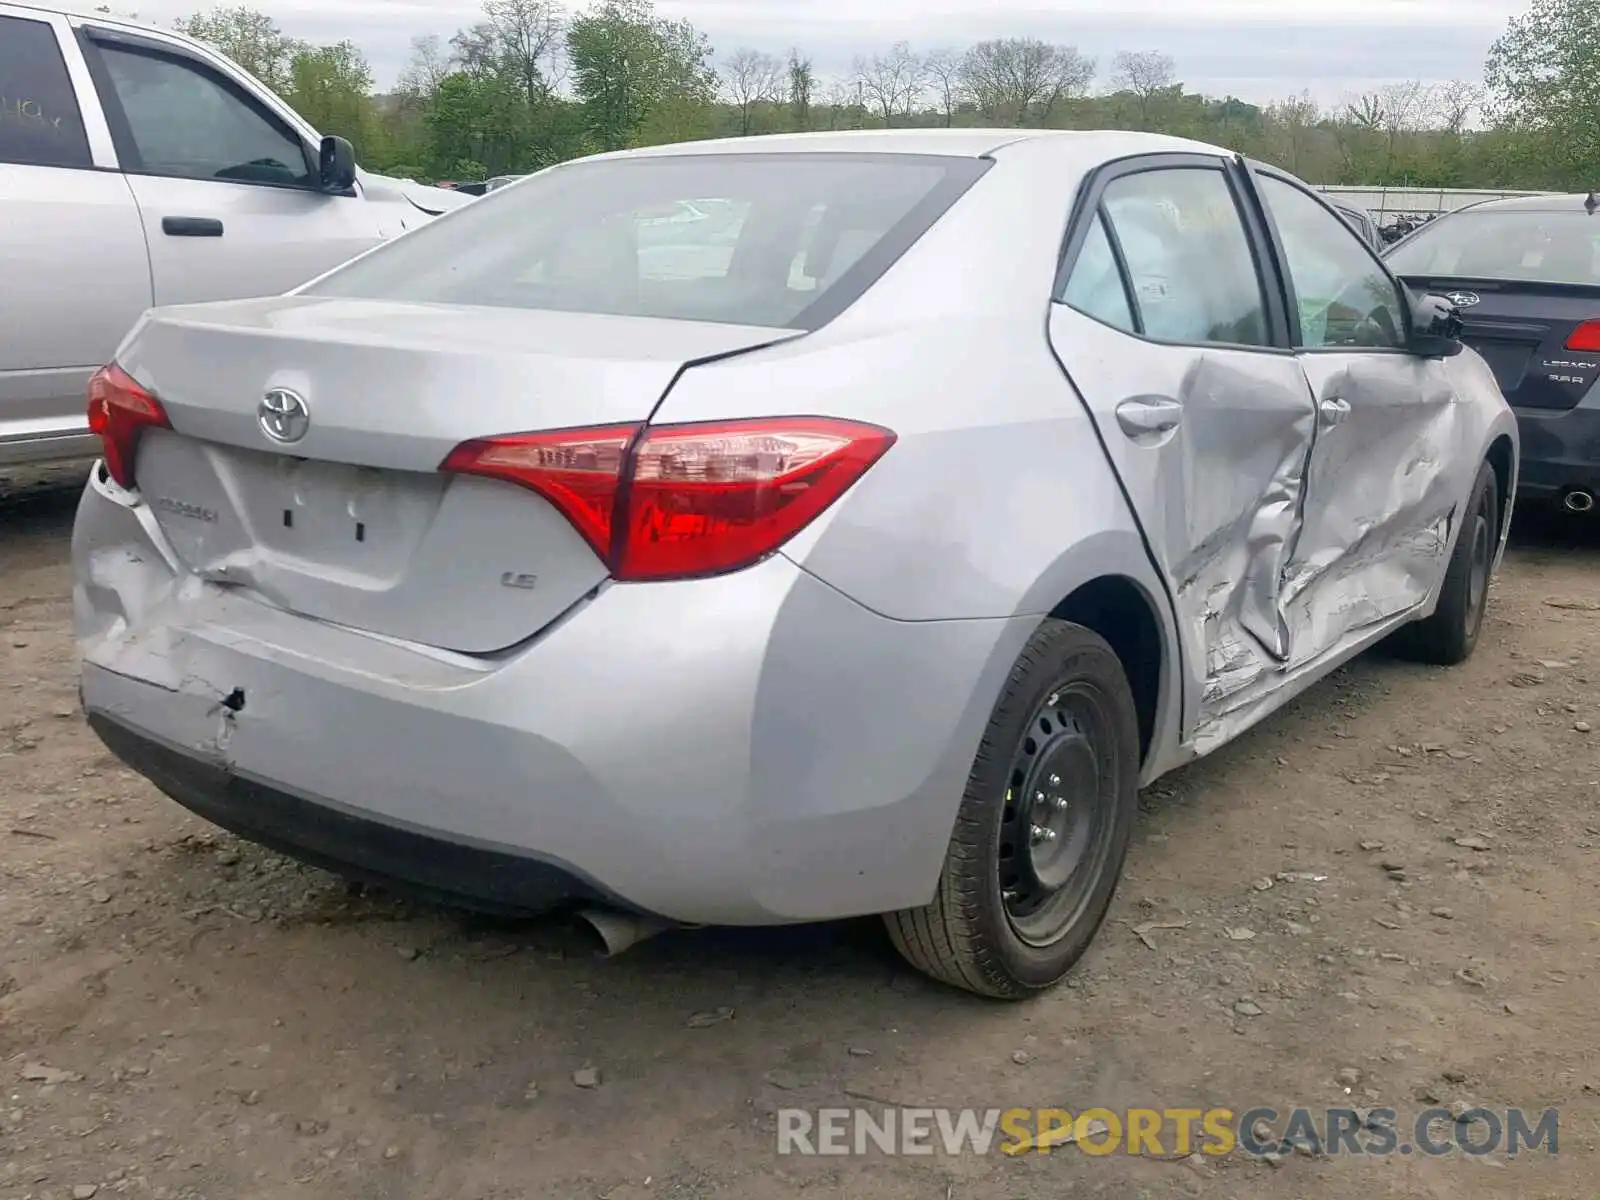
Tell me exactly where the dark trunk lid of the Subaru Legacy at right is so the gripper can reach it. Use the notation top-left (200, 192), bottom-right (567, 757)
top-left (1405, 278), bottom-right (1600, 411)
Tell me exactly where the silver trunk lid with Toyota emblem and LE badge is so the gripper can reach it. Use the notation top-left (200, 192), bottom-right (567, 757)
top-left (117, 296), bottom-right (797, 654)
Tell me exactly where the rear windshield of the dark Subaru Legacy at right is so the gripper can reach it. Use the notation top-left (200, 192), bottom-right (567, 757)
top-left (1386, 210), bottom-right (1600, 285)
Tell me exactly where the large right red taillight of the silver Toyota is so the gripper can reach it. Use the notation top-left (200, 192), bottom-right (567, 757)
top-left (440, 416), bottom-right (894, 581)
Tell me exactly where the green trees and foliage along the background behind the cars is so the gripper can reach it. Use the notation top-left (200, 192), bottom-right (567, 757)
top-left (178, 0), bottom-right (1600, 189)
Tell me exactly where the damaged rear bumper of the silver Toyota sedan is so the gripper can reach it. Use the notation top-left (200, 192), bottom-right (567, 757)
top-left (74, 472), bottom-right (1035, 925)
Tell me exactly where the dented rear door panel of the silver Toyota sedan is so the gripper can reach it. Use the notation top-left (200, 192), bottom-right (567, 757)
top-left (1050, 306), bottom-right (1315, 742)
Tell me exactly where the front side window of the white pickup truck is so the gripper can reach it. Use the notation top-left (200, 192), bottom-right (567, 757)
top-left (99, 45), bottom-right (312, 187)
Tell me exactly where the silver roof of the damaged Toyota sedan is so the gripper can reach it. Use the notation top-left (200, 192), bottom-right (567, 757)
top-left (581, 128), bottom-right (1234, 162)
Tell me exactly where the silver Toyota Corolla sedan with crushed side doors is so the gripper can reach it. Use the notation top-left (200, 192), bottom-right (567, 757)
top-left (74, 130), bottom-right (1518, 998)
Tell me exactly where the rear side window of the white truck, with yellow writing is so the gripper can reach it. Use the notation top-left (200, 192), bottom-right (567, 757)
top-left (0, 16), bottom-right (94, 166)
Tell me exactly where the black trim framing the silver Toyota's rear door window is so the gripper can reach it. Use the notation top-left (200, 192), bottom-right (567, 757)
top-left (1051, 152), bottom-right (1294, 355)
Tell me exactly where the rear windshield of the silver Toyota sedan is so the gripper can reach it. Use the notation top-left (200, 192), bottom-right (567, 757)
top-left (304, 154), bottom-right (987, 330)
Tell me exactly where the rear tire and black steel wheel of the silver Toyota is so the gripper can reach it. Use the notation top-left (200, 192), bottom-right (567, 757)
top-left (885, 619), bottom-right (1139, 1000)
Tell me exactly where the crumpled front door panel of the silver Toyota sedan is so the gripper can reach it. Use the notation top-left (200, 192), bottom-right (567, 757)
top-left (1283, 350), bottom-right (1478, 664)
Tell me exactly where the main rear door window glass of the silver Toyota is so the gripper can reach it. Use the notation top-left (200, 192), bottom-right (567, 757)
top-left (1101, 168), bottom-right (1270, 346)
